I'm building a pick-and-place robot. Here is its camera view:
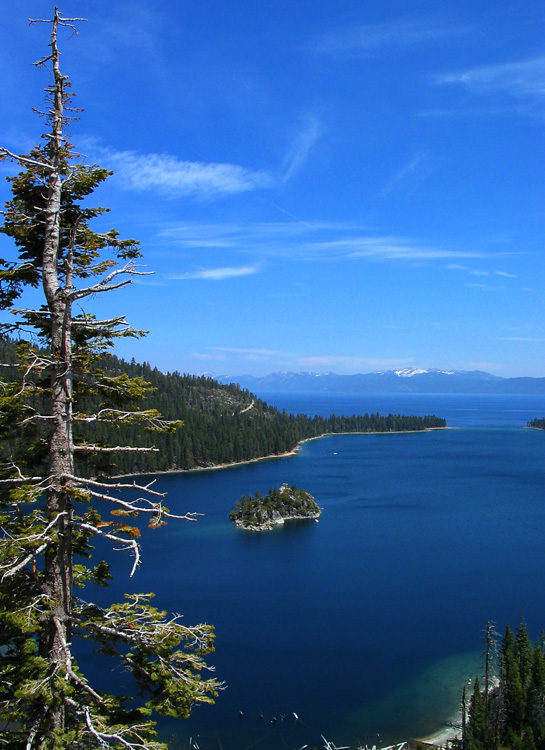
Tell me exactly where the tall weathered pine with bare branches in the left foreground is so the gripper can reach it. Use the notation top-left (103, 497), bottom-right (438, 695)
top-left (0, 9), bottom-right (219, 750)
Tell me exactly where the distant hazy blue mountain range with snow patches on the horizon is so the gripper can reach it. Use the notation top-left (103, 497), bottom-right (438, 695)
top-left (207, 367), bottom-right (545, 394)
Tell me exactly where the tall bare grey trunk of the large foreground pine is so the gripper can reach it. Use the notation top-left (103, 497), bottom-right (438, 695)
top-left (40, 9), bottom-right (74, 729)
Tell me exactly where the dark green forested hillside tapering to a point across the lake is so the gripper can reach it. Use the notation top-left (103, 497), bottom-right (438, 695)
top-left (0, 341), bottom-right (446, 474)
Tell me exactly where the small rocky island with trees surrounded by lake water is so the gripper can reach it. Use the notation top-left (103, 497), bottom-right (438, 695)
top-left (229, 483), bottom-right (322, 531)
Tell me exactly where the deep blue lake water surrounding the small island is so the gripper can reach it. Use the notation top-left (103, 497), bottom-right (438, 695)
top-left (85, 394), bottom-right (545, 750)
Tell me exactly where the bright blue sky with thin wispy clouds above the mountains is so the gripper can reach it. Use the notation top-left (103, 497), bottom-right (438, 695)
top-left (0, 0), bottom-right (545, 377)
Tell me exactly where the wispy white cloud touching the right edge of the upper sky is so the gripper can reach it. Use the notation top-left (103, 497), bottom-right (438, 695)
top-left (436, 57), bottom-right (545, 97)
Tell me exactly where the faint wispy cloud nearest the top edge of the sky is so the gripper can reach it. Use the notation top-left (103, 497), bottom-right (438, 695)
top-left (311, 19), bottom-right (466, 57)
